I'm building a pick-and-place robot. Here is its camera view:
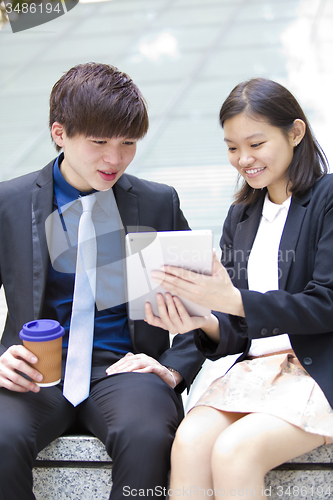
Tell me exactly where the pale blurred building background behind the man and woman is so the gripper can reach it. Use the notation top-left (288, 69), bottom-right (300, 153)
top-left (0, 0), bottom-right (333, 406)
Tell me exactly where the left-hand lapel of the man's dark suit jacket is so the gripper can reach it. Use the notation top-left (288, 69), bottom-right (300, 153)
top-left (31, 161), bottom-right (53, 318)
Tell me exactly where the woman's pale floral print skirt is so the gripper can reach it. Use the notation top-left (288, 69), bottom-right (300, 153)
top-left (195, 351), bottom-right (333, 444)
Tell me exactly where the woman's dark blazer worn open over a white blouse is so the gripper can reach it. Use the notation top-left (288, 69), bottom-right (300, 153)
top-left (196, 175), bottom-right (333, 406)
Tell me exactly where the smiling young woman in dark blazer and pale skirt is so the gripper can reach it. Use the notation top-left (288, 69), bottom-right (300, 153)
top-left (146, 79), bottom-right (333, 498)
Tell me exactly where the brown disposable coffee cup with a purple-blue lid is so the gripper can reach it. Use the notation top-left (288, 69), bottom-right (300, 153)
top-left (19, 319), bottom-right (65, 387)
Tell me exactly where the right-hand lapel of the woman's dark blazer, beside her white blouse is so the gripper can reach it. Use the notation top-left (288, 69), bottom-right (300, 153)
top-left (278, 189), bottom-right (312, 290)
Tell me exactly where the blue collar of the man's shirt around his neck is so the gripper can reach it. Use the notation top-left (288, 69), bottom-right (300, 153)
top-left (53, 153), bottom-right (116, 215)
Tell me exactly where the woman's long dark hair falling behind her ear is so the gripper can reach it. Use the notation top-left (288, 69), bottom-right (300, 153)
top-left (220, 78), bottom-right (328, 204)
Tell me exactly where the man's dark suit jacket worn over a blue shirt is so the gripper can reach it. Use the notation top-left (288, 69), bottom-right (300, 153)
top-left (0, 161), bottom-right (204, 392)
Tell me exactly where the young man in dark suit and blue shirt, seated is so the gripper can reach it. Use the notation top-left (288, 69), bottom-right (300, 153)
top-left (0, 63), bottom-right (203, 500)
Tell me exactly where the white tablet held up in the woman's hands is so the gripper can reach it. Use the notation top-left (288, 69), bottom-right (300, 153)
top-left (125, 230), bottom-right (213, 320)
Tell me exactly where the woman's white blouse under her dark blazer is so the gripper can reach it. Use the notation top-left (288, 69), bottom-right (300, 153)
top-left (247, 193), bottom-right (292, 356)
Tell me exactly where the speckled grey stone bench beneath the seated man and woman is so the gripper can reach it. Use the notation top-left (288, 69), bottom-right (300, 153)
top-left (33, 436), bottom-right (333, 500)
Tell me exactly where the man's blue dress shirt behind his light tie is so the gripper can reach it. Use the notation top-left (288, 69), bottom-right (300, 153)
top-left (42, 155), bottom-right (133, 354)
